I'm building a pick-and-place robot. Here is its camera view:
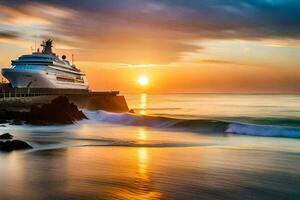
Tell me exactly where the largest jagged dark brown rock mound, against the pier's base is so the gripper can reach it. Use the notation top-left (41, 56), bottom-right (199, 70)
top-left (26, 96), bottom-right (87, 125)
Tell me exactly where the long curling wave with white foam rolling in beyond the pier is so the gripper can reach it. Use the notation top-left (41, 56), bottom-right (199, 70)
top-left (86, 111), bottom-right (300, 138)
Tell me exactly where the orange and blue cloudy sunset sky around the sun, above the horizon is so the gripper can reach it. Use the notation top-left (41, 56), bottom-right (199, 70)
top-left (0, 0), bottom-right (300, 93)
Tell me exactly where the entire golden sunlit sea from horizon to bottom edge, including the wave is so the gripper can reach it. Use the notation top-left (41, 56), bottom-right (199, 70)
top-left (0, 93), bottom-right (300, 200)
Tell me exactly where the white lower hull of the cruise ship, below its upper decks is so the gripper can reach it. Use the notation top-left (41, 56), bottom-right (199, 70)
top-left (2, 69), bottom-right (88, 90)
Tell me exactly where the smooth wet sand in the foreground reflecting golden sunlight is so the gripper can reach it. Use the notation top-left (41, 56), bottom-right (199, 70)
top-left (0, 141), bottom-right (300, 200)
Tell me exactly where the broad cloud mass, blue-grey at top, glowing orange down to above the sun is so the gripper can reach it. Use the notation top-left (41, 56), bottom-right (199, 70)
top-left (0, 0), bottom-right (300, 64)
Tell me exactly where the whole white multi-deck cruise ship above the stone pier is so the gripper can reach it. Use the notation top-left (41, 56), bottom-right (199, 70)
top-left (2, 39), bottom-right (89, 90)
